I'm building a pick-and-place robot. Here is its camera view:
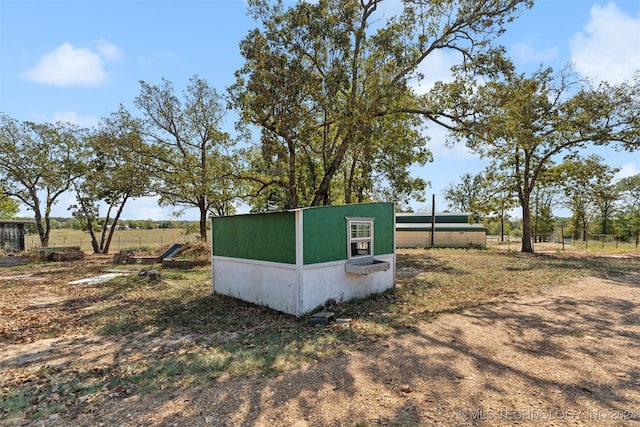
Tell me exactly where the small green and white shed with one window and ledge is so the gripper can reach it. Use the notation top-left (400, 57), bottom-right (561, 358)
top-left (211, 203), bottom-right (395, 316)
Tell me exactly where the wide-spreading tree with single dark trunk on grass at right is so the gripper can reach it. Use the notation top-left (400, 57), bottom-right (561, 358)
top-left (438, 65), bottom-right (640, 252)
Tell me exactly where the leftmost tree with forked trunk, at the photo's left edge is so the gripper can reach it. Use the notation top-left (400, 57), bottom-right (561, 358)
top-left (0, 114), bottom-right (85, 247)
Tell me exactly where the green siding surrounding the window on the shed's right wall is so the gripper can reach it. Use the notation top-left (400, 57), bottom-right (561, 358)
top-left (303, 203), bottom-right (395, 265)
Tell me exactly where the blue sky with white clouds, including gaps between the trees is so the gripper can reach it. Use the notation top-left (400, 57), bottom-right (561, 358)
top-left (0, 0), bottom-right (640, 220)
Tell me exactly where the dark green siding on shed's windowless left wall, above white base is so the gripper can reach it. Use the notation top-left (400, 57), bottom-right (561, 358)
top-left (211, 212), bottom-right (296, 264)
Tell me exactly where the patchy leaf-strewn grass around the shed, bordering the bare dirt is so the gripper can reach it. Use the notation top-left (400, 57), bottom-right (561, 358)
top-left (0, 249), bottom-right (637, 420)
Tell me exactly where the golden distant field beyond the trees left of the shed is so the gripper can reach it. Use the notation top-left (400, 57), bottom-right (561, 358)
top-left (25, 228), bottom-right (201, 252)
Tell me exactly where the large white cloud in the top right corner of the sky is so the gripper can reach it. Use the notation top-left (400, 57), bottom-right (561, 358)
top-left (569, 3), bottom-right (640, 84)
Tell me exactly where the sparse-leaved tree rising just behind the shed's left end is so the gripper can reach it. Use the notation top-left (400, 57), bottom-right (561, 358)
top-left (131, 76), bottom-right (238, 240)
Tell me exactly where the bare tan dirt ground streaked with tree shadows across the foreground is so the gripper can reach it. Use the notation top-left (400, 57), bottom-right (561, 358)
top-left (0, 256), bottom-right (640, 427)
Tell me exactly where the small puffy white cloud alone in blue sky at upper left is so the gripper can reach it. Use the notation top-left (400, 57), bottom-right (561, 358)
top-left (25, 40), bottom-right (121, 86)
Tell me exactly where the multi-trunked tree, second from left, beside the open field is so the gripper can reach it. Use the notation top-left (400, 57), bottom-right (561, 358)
top-left (70, 114), bottom-right (150, 253)
